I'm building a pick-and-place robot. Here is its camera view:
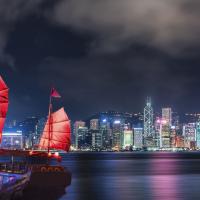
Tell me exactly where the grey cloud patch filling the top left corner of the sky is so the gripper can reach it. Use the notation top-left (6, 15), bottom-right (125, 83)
top-left (0, 0), bottom-right (45, 67)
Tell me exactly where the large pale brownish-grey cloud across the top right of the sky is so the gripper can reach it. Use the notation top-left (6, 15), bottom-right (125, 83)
top-left (51, 0), bottom-right (200, 53)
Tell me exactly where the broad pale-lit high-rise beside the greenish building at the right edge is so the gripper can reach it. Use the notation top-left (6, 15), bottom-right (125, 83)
top-left (183, 123), bottom-right (196, 149)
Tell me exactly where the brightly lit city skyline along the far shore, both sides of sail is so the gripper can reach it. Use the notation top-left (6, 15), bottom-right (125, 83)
top-left (2, 103), bottom-right (200, 151)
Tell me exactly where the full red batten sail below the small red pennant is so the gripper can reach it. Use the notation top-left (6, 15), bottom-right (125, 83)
top-left (39, 108), bottom-right (71, 151)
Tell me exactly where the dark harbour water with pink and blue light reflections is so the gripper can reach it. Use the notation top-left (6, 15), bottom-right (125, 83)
top-left (59, 153), bottom-right (200, 200)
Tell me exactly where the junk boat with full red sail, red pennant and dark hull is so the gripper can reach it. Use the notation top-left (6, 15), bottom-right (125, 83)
top-left (26, 88), bottom-right (71, 187)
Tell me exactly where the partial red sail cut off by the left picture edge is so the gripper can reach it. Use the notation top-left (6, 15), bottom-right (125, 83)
top-left (0, 76), bottom-right (9, 142)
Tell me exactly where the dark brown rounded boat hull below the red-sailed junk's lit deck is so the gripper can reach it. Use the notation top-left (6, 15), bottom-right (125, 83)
top-left (23, 165), bottom-right (71, 200)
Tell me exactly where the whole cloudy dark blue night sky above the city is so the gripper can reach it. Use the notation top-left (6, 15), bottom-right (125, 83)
top-left (0, 0), bottom-right (200, 120)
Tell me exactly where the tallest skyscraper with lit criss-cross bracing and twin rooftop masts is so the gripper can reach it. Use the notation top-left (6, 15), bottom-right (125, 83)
top-left (144, 97), bottom-right (154, 147)
